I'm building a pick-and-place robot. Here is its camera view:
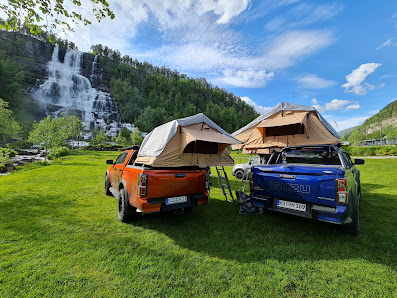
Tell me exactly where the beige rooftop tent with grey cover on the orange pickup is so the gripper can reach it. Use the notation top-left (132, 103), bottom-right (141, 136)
top-left (136, 113), bottom-right (241, 168)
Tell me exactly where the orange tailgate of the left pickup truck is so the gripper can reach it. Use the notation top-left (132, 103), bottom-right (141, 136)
top-left (147, 169), bottom-right (206, 198)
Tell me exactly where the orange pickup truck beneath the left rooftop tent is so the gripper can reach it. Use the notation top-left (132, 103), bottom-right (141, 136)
top-left (105, 146), bottom-right (210, 222)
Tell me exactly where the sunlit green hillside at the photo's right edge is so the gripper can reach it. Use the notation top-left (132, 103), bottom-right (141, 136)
top-left (346, 100), bottom-right (397, 144)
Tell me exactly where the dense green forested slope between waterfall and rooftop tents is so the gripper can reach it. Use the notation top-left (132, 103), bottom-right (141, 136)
top-left (94, 46), bottom-right (258, 132)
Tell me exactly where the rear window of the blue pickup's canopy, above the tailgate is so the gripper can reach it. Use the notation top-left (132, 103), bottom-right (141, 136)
top-left (279, 148), bottom-right (341, 165)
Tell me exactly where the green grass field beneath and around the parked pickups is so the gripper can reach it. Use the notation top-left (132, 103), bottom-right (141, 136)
top-left (0, 152), bottom-right (397, 297)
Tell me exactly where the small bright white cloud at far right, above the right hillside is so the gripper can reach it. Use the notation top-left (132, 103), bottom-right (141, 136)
top-left (342, 63), bottom-right (382, 95)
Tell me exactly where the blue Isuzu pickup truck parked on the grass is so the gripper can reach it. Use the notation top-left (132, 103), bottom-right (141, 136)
top-left (249, 145), bottom-right (364, 235)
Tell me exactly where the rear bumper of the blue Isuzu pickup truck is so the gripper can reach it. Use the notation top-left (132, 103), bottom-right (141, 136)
top-left (250, 194), bottom-right (350, 224)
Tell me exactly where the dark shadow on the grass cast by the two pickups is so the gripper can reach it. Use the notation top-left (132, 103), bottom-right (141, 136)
top-left (131, 190), bottom-right (397, 267)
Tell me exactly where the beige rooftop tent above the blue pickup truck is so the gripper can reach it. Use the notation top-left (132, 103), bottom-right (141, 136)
top-left (232, 102), bottom-right (340, 154)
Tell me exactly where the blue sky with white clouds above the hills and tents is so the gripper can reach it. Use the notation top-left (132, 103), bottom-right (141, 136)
top-left (63, 0), bottom-right (397, 130)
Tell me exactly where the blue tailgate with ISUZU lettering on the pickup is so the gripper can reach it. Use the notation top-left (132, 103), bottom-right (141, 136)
top-left (253, 164), bottom-right (340, 207)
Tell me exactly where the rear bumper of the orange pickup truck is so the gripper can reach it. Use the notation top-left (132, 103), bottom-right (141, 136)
top-left (136, 193), bottom-right (209, 213)
